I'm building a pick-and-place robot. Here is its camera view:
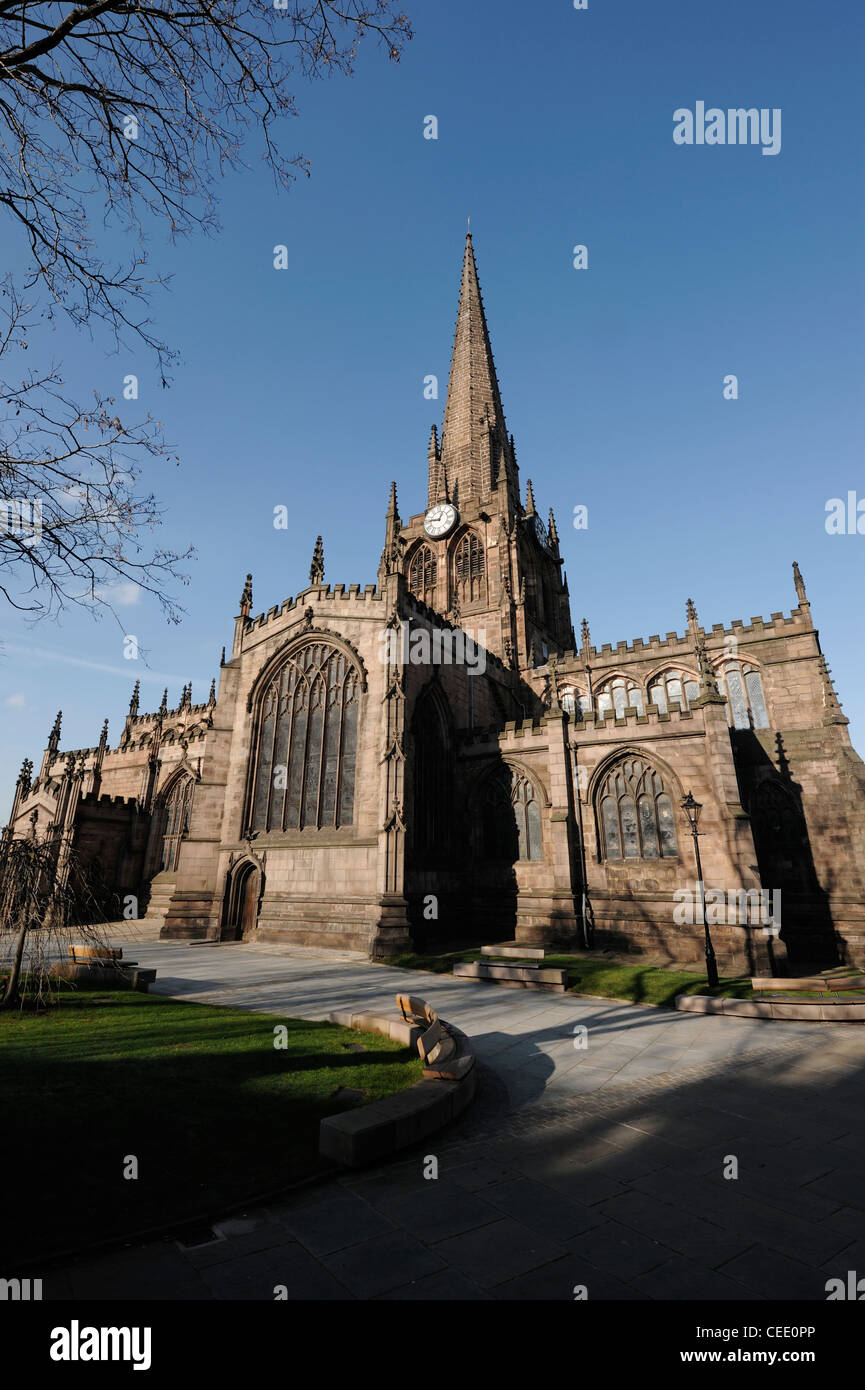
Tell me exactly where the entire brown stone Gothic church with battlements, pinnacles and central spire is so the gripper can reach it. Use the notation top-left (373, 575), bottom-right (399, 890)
top-left (6, 235), bottom-right (865, 972)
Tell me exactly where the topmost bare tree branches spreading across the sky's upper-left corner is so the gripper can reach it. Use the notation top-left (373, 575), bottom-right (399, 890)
top-left (0, 0), bottom-right (412, 373)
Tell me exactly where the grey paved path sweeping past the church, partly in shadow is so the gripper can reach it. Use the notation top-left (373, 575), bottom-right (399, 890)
top-left (46, 933), bottom-right (865, 1301)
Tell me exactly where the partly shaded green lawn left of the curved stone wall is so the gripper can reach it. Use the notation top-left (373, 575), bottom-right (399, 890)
top-left (0, 991), bottom-right (423, 1269)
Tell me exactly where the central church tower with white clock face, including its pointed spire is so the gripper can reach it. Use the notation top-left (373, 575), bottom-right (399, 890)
top-left (380, 234), bottom-right (574, 670)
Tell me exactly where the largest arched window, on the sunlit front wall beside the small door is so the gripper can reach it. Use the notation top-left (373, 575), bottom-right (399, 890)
top-left (249, 642), bottom-right (360, 831)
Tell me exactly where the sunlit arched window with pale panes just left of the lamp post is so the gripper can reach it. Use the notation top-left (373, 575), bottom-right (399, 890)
top-left (597, 758), bottom-right (679, 859)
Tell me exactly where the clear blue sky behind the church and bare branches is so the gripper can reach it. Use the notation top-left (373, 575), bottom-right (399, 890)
top-left (0, 0), bottom-right (865, 819)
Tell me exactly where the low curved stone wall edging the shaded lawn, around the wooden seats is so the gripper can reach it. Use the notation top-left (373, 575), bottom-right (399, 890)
top-left (318, 1013), bottom-right (476, 1168)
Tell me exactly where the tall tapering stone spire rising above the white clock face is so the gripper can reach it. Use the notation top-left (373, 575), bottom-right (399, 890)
top-left (430, 232), bottom-right (519, 507)
